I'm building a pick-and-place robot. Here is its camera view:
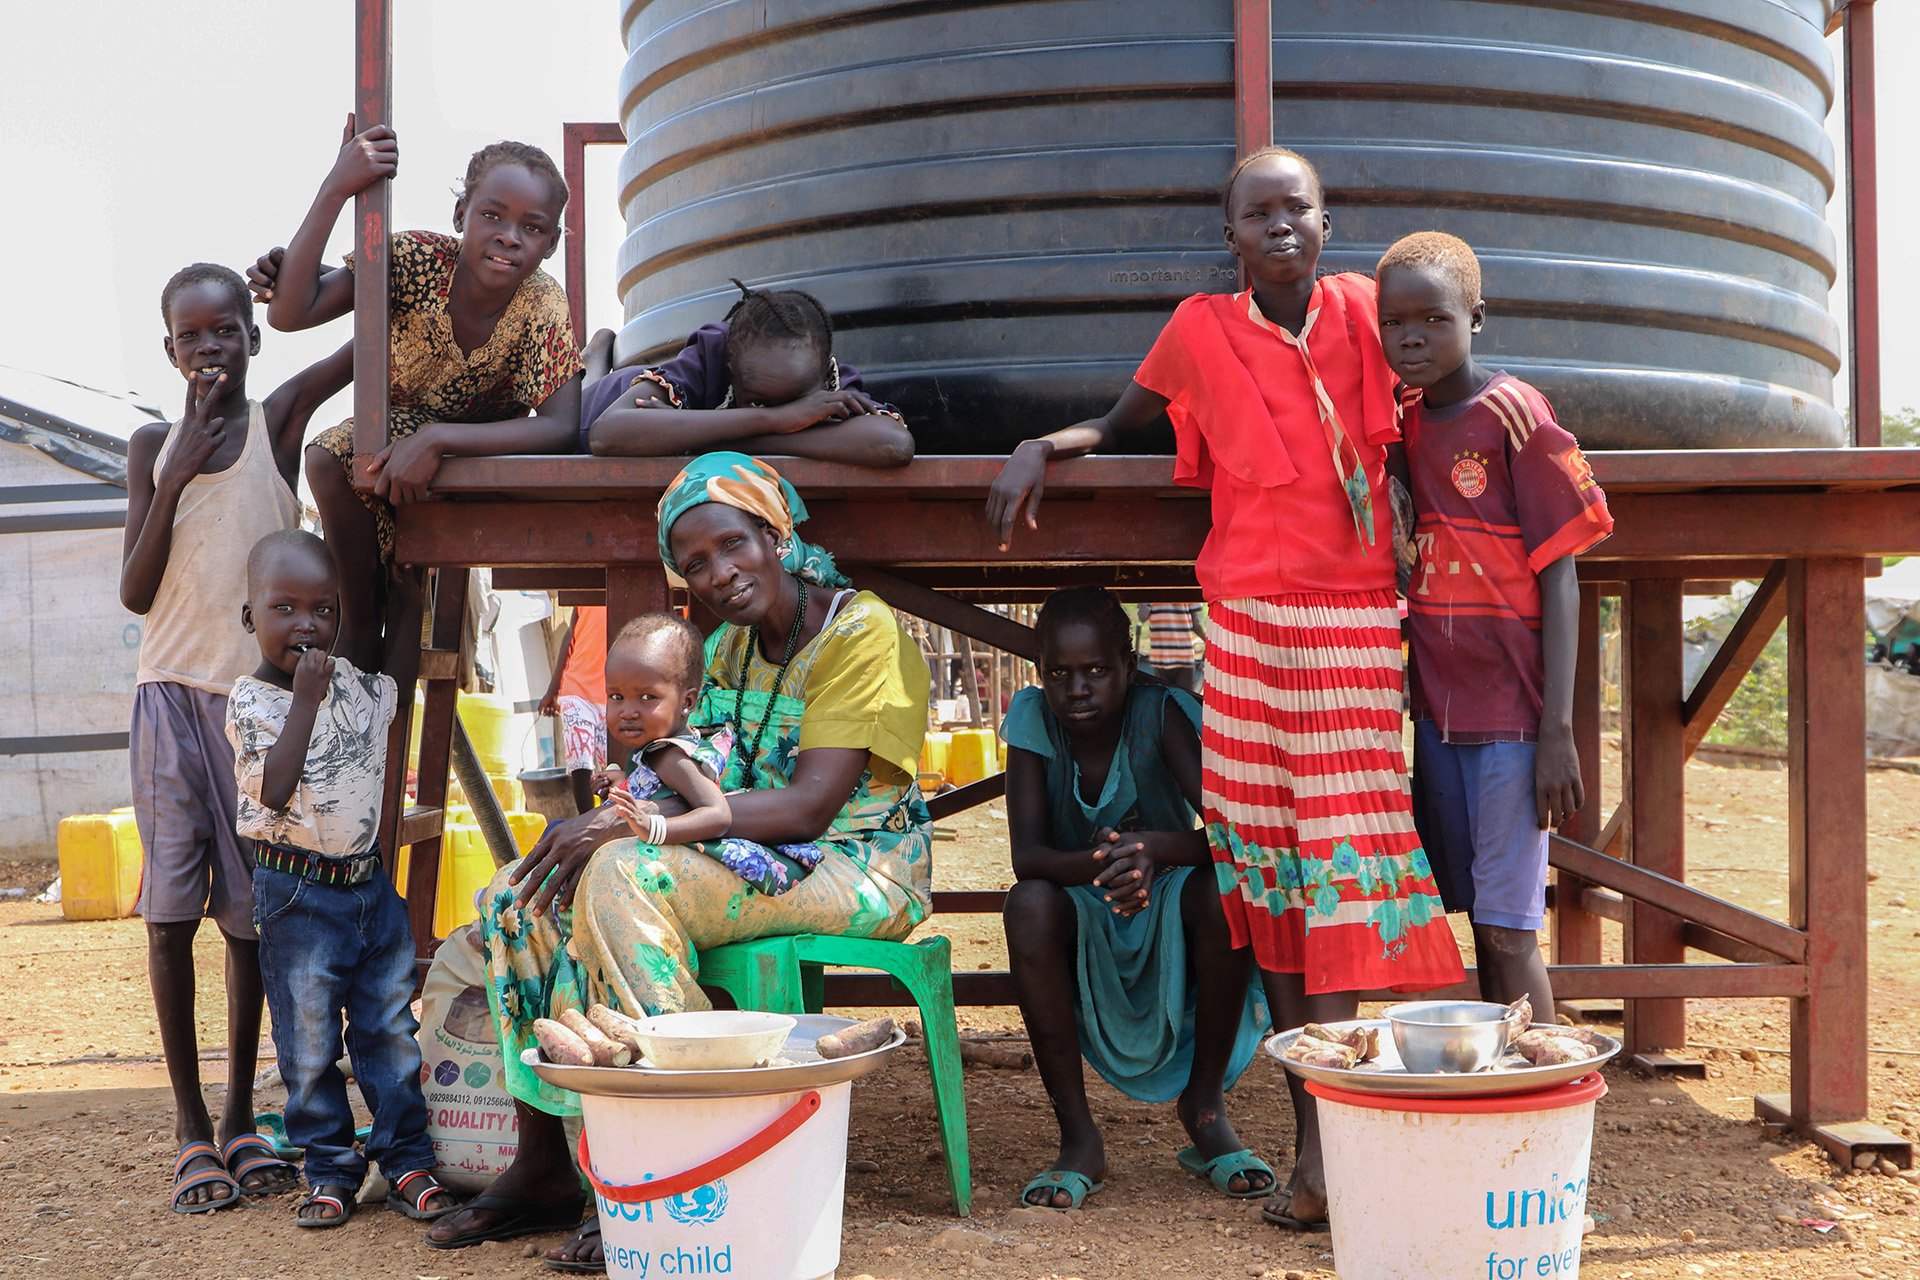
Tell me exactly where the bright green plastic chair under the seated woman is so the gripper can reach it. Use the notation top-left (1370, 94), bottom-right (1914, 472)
top-left (699, 933), bottom-right (973, 1217)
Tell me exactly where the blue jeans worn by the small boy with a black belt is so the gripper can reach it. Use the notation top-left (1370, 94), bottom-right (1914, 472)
top-left (253, 867), bottom-right (438, 1190)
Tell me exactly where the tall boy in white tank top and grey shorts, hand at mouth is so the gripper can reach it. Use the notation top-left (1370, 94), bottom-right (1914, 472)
top-left (121, 263), bottom-right (353, 1213)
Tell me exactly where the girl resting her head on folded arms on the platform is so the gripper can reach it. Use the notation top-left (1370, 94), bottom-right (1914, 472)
top-left (580, 280), bottom-right (914, 466)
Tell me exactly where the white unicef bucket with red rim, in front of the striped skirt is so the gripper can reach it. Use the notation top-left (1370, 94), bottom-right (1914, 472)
top-left (1308, 1073), bottom-right (1607, 1280)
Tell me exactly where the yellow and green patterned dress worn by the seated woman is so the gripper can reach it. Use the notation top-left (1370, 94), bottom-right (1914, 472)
top-left (482, 589), bottom-right (933, 1115)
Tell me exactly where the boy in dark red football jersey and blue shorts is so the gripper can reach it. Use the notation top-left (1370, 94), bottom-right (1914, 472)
top-left (1377, 232), bottom-right (1613, 1021)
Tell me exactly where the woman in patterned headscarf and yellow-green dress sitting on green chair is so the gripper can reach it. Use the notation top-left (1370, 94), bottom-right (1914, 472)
top-left (428, 453), bottom-right (933, 1270)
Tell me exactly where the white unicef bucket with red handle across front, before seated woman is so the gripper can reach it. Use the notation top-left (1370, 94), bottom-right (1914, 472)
top-left (580, 1080), bottom-right (852, 1280)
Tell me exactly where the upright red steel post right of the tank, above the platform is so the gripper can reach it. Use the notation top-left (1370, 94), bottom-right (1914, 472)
top-left (1839, 0), bottom-right (1880, 445)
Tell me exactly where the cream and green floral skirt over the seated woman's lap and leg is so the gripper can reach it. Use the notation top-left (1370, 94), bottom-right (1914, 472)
top-left (480, 829), bottom-right (931, 1115)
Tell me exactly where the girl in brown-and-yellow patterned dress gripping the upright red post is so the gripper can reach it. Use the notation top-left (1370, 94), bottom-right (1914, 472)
top-left (248, 119), bottom-right (580, 652)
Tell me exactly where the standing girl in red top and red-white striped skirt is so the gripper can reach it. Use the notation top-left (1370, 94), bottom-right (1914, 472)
top-left (987, 148), bottom-right (1463, 1230)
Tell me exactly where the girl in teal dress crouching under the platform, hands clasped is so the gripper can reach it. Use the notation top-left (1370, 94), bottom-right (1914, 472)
top-left (1000, 587), bottom-right (1273, 1209)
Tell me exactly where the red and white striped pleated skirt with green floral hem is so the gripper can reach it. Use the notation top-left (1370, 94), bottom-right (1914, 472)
top-left (1200, 591), bottom-right (1465, 996)
